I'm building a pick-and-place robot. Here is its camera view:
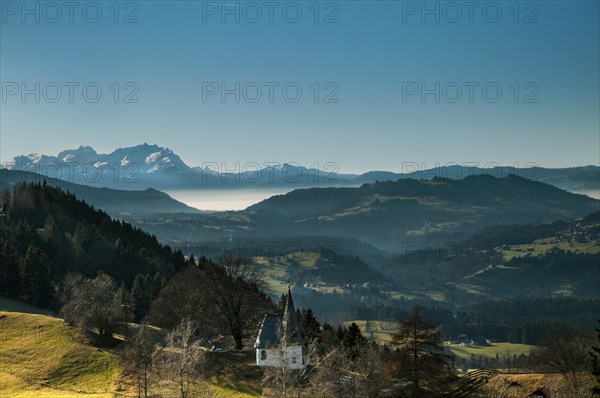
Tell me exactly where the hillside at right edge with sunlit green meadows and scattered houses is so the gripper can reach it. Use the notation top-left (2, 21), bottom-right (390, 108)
top-left (377, 212), bottom-right (600, 302)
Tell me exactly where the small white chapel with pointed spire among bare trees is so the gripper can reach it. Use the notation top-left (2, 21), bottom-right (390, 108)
top-left (254, 287), bottom-right (308, 369)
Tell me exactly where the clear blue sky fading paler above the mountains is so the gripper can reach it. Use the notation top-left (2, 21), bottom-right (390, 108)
top-left (0, 0), bottom-right (600, 172)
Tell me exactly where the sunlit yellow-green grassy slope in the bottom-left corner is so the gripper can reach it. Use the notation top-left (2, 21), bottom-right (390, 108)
top-left (0, 312), bottom-right (121, 397)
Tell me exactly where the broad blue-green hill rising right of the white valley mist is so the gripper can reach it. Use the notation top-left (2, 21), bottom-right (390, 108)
top-left (126, 175), bottom-right (600, 252)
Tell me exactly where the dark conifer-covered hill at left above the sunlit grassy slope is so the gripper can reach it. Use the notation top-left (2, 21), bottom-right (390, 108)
top-left (0, 184), bottom-right (185, 307)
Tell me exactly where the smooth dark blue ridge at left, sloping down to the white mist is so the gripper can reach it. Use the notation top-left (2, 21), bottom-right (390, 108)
top-left (0, 169), bottom-right (200, 217)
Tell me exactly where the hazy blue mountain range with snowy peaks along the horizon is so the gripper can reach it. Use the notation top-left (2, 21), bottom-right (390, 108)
top-left (4, 144), bottom-right (600, 197)
